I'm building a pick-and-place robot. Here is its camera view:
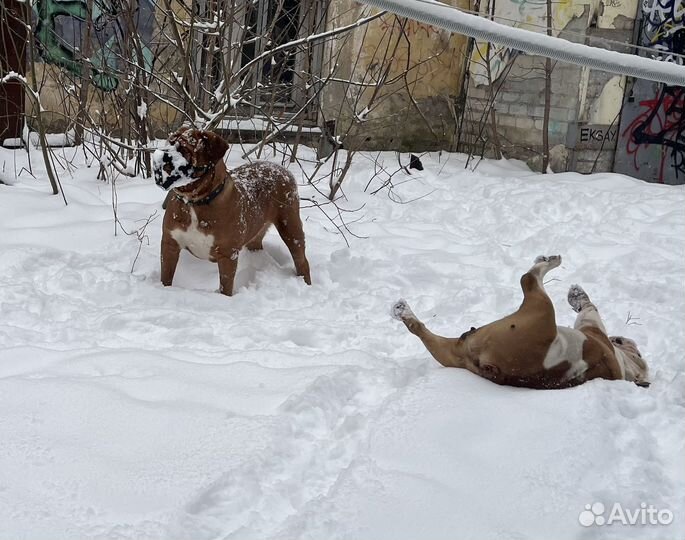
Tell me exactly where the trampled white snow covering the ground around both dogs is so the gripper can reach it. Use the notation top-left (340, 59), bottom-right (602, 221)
top-left (0, 143), bottom-right (685, 540)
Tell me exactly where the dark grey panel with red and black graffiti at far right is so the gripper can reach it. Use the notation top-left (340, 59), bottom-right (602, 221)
top-left (614, 0), bottom-right (685, 184)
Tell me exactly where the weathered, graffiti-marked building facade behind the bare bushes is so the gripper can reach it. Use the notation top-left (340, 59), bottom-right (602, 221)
top-left (0, 0), bottom-right (685, 183)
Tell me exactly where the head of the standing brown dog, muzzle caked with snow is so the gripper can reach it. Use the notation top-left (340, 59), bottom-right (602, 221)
top-left (152, 128), bottom-right (228, 190)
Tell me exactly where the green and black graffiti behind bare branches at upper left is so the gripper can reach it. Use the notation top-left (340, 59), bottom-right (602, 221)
top-left (34, 0), bottom-right (154, 91)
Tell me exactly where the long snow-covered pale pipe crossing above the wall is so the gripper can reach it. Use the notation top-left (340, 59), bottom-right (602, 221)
top-left (360, 0), bottom-right (685, 86)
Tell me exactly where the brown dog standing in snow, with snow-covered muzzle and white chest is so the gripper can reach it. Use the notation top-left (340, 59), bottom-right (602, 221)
top-left (153, 129), bottom-right (311, 295)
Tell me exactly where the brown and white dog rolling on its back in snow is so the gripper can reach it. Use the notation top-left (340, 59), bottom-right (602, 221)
top-left (392, 255), bottom-right (649, 388)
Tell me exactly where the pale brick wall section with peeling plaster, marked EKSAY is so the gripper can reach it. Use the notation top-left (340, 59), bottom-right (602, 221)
top-left (460, 0), bottom-right (637, 172)
